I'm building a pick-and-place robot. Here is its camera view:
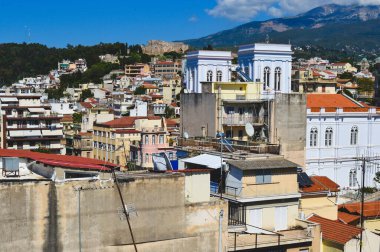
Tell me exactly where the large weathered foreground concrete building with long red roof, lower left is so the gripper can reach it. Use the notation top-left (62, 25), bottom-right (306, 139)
top-left (0, 150), bottom-right (228, 252)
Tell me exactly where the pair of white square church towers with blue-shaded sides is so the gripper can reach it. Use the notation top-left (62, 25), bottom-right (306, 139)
top-left (185, 43), bottom-right (293, 94)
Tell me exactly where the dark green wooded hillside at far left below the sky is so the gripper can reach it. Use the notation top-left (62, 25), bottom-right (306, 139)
top-left (0, 43), bottom-right (146, 85)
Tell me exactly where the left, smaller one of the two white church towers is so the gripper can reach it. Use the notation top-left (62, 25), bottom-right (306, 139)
top-left (185, 50), bottom-right (232, 93)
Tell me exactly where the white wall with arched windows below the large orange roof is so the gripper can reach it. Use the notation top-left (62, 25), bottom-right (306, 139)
top-left (306, 110), bottom-right (380, 188)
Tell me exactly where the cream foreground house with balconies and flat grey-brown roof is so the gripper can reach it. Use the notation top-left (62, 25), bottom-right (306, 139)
top-left (220, 157), bottom-right (320, 251)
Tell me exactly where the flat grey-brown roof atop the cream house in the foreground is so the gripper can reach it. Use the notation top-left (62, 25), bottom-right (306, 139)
top-left (227, 159), bottom-right (299, 170)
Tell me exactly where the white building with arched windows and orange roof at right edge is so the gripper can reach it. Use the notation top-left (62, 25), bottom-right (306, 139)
top-left (306, 94), bottom-right (380, 189)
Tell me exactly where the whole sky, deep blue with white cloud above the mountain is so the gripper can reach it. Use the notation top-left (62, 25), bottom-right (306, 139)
top-left (0, 0), bottom-right (374, 47)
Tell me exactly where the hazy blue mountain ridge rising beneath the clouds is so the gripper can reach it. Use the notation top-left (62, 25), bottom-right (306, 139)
top-left (181, 4), bottom-right (380, 50)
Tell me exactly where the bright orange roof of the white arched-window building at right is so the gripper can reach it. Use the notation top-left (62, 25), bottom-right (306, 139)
top-left (306, 94), bottom-right (360, 108)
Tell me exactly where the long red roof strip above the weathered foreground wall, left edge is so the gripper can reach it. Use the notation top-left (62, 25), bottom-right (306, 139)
top-left (0, 149), bottom-right (116, 170)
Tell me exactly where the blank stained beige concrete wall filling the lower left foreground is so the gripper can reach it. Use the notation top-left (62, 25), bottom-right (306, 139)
top-left (0, 174), bottom-right (227, 251)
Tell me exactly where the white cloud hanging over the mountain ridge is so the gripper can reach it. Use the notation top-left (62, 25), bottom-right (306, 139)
top-left (206, 0), bottom-right (380, 21)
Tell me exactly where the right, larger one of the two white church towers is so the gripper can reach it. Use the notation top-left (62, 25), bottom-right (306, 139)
top-left (238, 43), bottom-right (293, 93)
